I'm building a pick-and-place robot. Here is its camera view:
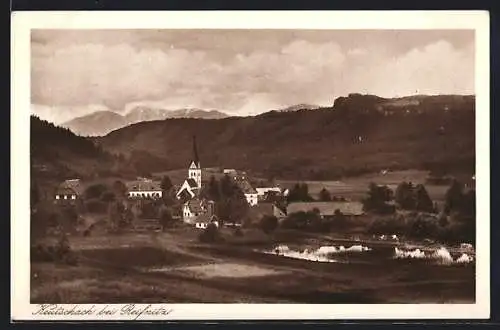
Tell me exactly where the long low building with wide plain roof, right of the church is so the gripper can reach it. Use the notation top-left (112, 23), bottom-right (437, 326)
top-left (286, 201), bottom-right (364, 218)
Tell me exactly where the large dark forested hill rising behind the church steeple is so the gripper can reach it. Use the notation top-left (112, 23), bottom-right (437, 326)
top-left (95, 94), bottom-right (475, 179)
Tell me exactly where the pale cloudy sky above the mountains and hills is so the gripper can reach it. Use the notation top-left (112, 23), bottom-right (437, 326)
top-left (31, 30), bottom-right (475, 123)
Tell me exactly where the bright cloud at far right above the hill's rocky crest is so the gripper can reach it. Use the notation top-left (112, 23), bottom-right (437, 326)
top-left (346, 40), bottom-right (475, 97)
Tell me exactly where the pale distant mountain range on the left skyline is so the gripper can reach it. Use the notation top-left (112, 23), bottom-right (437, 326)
top-left (61, 106), bottom-right (229, 136)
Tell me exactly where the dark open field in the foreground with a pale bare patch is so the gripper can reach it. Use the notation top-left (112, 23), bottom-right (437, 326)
top-left (31, 228), bottom-right (475, 303)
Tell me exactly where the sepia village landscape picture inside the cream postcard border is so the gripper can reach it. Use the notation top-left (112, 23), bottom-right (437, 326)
top-left (9, 10), bottom-right (489, 317)
